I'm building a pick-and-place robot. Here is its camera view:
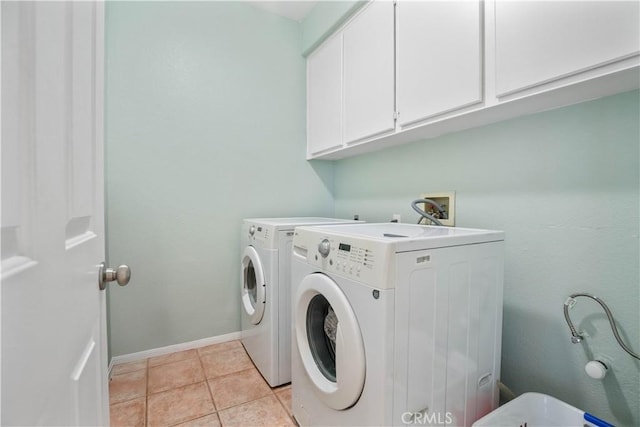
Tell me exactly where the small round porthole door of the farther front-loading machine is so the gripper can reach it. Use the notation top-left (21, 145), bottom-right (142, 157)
top-left (241, 246), bottom-right (267, 325)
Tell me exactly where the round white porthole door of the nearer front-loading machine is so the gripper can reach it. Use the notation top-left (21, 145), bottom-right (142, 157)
top-left (294, 273), bottom-right (366, 410)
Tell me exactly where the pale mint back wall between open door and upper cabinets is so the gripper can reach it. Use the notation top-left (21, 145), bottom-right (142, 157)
top-left (105, 2), bottom-right (333, 356)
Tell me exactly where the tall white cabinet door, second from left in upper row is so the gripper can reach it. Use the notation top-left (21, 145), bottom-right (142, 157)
top-left (343, 1), bottom-right (395, 144)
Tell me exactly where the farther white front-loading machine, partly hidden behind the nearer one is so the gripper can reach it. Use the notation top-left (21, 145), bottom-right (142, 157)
top-left (240, 217), bottom-right (356, 387)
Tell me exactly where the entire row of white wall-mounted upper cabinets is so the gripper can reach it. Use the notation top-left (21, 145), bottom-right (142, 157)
top-left (307, 0), bottom-right (640, 159)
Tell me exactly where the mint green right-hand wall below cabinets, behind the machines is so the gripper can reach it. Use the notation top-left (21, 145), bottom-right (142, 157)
top-left (334, 92), bottom-right (640, 426)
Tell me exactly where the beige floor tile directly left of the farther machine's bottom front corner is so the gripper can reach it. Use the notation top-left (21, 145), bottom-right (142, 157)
top-left (209, 368), bottom-right (271, 410)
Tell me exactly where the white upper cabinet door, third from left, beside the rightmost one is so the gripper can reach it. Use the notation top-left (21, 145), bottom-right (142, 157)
top-left (397, 0), bottom-right (482, 126)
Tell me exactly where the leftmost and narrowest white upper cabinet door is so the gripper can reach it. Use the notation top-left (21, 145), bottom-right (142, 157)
top-left (307, 33), bottom-right (342, 156)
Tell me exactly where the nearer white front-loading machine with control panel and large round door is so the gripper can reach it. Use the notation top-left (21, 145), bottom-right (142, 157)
top-left (291, 223), bottom-right (504, 426)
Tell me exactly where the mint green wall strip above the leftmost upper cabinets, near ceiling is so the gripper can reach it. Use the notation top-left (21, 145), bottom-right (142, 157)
top-left (302, 0), bottom-right (367, 55)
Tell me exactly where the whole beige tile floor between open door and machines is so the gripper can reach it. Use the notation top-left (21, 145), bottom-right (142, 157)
top-left (109, 341), bottom-right (296, 427)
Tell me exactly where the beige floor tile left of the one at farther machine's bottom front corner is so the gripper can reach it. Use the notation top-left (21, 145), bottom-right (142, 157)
top-left (147, 382), bottom-right (215, 426)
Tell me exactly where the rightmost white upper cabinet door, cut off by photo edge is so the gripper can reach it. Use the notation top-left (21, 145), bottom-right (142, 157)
top-left (495, 0), bottom-right (640, 96)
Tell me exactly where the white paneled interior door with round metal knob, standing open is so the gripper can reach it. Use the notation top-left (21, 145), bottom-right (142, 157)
top-left (0, 1), bottom-right (109, 425)
